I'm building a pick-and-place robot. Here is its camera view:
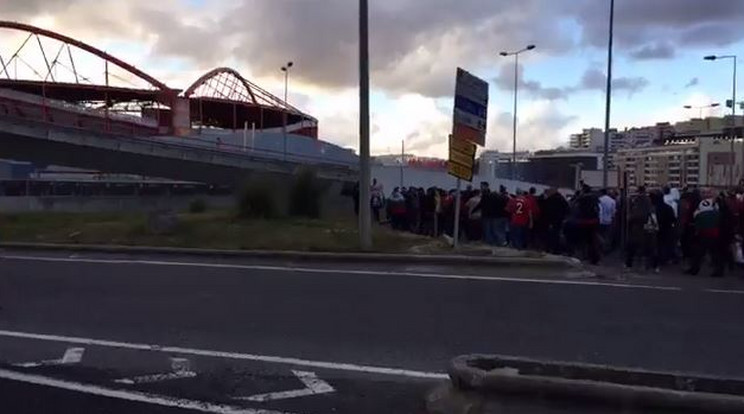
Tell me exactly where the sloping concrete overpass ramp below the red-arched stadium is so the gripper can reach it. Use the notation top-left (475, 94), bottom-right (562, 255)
top-left (0, 113), bottom-right (357, 185)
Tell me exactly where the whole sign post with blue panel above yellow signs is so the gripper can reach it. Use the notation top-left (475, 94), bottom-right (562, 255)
top-left (447, 68), bottom-right (488, 248)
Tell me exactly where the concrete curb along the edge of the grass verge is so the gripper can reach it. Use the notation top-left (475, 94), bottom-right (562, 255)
top-left (0, 242), bottom-right (580, 268)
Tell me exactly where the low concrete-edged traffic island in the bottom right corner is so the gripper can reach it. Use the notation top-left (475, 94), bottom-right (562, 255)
top-left (426, 355), bottom-right (744, 414)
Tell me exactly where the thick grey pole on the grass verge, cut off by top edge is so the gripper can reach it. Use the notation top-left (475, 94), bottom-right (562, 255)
top-left (359, 0), bottom-right (372, 250)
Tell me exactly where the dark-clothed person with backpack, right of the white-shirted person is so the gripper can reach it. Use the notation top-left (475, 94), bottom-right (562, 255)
top-left (625, 185), bottom-right (659, 269)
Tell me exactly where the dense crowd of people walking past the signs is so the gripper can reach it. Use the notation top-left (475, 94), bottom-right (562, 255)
top-left (364, 181), bottom-right (744, 277)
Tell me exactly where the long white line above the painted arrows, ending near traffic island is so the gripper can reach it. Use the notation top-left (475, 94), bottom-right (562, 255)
top-left (0, 330), bottom-right (449, 380)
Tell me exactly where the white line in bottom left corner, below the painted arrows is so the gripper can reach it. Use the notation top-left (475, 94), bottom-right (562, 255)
top-left (0, 369), bottom-right (290, 414)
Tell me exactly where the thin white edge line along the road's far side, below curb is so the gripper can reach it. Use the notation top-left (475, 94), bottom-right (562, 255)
top-left (0, 255), bottom-right (682, 291)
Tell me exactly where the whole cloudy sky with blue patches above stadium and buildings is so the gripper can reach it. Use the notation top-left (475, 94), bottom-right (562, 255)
top-left (0, 0), bottom-right (744, 156)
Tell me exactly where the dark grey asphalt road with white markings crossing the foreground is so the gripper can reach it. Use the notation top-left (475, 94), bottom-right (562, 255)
top-left (0, 252), bottom-right (744, 414)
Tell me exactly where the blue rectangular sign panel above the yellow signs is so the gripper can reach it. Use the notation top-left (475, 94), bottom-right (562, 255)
top-left (452, 68), bottom-right (488, 146)
